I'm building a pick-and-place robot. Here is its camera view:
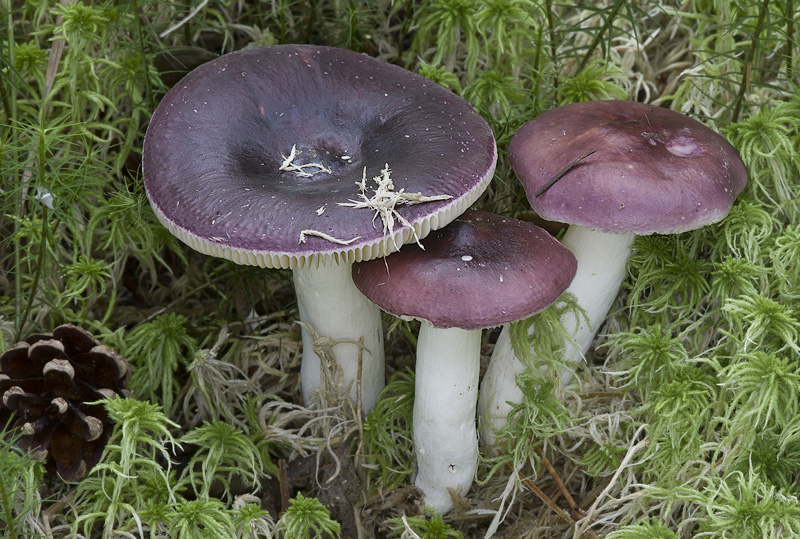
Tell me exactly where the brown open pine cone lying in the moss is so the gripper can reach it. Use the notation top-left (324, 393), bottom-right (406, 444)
top-left (0, 324), bottom-right (131, 481)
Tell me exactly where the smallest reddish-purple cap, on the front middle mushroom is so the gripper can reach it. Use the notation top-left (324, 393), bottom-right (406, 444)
top-left (353, 210), bottom-right (578, 329)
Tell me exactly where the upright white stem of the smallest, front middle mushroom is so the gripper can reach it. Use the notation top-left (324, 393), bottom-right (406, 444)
top-left (414, 322), bottom-right (481, 513)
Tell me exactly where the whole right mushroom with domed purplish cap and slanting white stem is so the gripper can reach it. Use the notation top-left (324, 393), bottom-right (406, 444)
top-left (479, 101), bottom-right (747, 445)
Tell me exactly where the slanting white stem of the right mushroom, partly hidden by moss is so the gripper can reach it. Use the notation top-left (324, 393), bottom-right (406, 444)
top-left (478, 225), bottom-right (636, 446)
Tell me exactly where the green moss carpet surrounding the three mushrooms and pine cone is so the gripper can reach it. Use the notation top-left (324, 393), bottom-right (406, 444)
top-left (0, 0), bottom-right (800, 538)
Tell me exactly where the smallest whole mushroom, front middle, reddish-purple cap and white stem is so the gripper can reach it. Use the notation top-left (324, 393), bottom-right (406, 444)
top-left (353, 210), bottom-right (576, 513)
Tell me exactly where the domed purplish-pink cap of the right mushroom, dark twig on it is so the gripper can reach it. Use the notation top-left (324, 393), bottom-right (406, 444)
top-left (508, 101), bottom-right (747, 234)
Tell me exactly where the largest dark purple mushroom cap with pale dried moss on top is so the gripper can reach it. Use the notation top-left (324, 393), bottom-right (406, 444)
top-left (142, 45), bottom-right (497, 268)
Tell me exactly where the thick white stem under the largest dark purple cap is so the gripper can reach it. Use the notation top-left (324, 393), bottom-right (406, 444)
top-left (293, 262), bottom-right (384, 413)
